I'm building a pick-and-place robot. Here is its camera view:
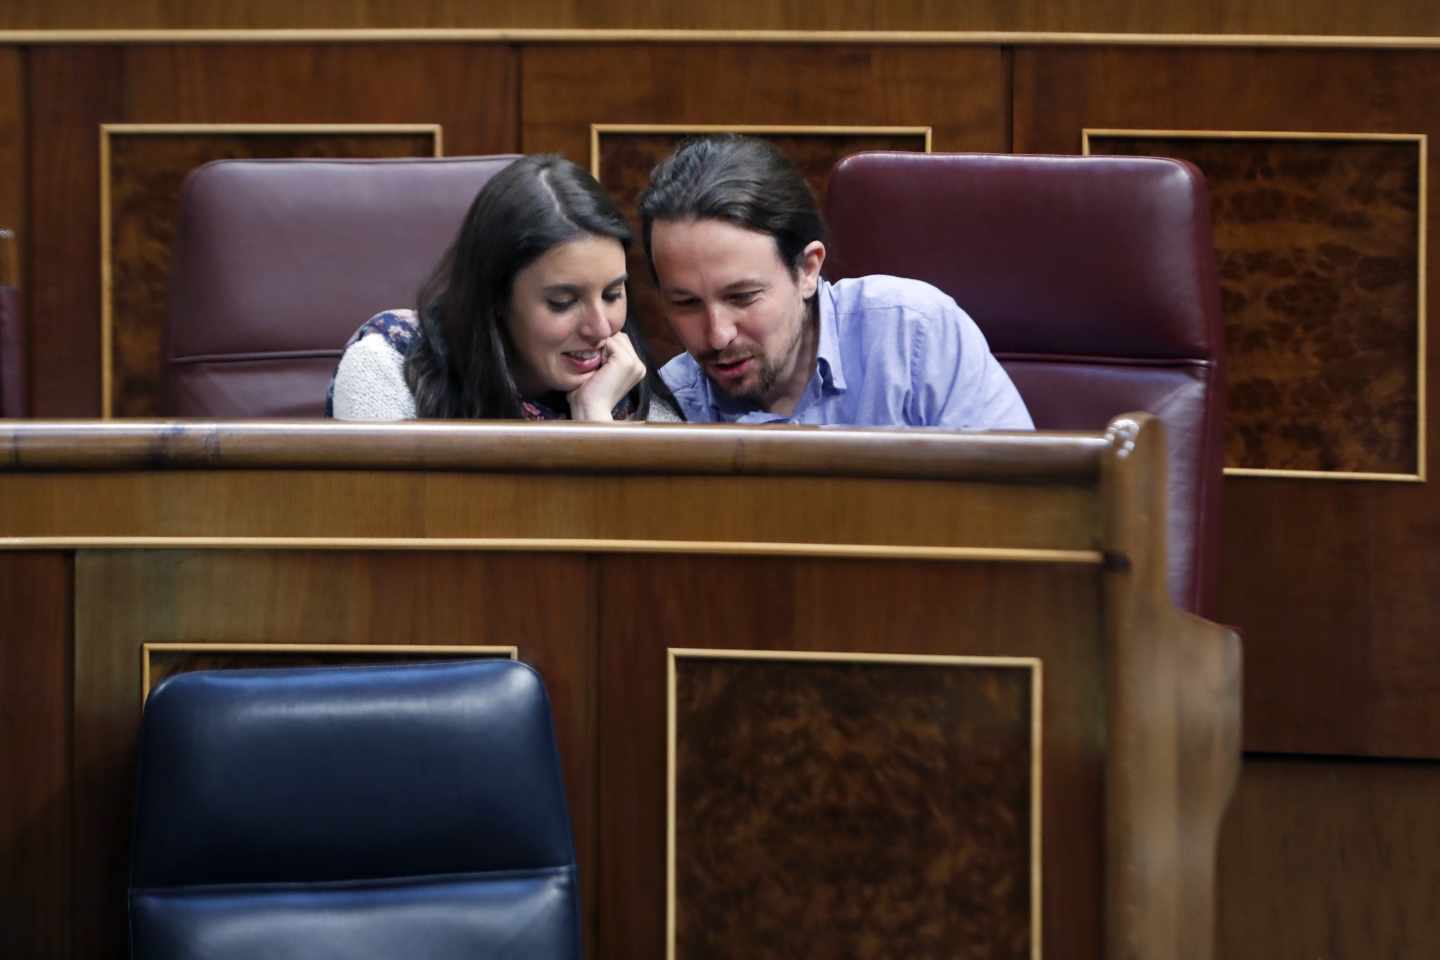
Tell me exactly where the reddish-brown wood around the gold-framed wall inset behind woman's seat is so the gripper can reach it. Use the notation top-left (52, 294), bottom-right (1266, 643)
top-left (27, 43), bottom-right (518, 417)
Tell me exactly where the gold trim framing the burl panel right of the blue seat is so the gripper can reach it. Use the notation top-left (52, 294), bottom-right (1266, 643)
top-left (665, 646), bottom-right (1044, 960)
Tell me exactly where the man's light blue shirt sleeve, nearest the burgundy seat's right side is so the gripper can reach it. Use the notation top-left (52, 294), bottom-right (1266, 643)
top-left (909, 296), bottom-right (1035, 430)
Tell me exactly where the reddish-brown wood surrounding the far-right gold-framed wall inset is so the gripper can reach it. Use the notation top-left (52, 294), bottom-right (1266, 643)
top-left (1015, 49), bottom-right (1440, 757)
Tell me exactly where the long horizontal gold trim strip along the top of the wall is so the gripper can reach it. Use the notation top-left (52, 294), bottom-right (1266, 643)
top-left (14, 27), bottom-right (1440, 50)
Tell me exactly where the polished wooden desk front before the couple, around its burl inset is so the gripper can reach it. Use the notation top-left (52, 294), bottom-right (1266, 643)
top-left (0, 417), bottom-right (1238, 960)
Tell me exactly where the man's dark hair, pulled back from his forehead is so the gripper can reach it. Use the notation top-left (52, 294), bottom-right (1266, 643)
top-left (639, 134), bottom-right (825, 279)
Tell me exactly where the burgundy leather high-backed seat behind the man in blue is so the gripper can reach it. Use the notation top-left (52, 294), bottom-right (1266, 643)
top-left (825, 153), bottom-right (1225, 616)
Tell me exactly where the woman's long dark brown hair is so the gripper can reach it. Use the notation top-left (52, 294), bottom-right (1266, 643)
top-left (405, 155), bottom-right (670, 420)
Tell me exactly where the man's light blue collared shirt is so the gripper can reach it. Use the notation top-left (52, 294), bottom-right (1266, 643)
top-left (660, 275), bottom-right (1035, 430)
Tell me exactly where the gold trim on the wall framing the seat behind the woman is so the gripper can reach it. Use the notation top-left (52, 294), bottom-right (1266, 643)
top-left (99, 124), bottom-right (445, 420)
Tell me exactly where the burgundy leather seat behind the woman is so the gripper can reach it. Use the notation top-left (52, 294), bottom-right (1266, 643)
top-left (166, 155), bottom-right (514, 417)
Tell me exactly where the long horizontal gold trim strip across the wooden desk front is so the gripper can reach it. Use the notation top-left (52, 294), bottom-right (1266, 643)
top-left (0, 537), bottom-right (1104, 566)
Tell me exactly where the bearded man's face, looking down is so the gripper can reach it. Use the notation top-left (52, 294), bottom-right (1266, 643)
top-left (649, 220), bottom-right (825, 413)
